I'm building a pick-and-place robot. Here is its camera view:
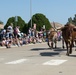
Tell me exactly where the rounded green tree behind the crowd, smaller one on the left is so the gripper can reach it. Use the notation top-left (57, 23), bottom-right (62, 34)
top-left (4, 16), bottom-right (26, 32)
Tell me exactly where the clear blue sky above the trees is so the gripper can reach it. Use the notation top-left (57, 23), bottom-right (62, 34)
top-left (0, 0), bottom-right (76, 24)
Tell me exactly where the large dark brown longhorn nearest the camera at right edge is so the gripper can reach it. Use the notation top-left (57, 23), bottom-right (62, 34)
top-left (60, 23), bottom-right (76, 56)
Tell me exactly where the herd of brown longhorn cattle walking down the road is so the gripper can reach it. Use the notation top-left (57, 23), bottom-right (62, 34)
top-left (48, 23), bottom-right (76, 56)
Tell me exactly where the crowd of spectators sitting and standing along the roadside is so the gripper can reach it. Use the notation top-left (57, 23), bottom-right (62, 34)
top-left (0, 24), bottom-right (46, 48)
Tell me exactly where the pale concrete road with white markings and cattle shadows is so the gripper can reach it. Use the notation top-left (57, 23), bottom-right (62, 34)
top-left (0, 42), bottom-right (76, 75)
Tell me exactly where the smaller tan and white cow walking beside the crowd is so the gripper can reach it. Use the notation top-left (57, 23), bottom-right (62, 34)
top-left (48, 28), bottom-right (57, 48)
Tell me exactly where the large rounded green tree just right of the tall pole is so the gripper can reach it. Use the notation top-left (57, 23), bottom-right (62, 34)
top-left (28, 13), bottom-right (51, 30)
